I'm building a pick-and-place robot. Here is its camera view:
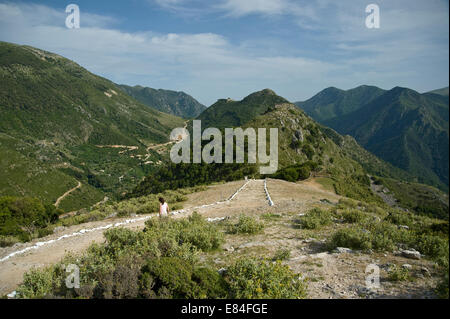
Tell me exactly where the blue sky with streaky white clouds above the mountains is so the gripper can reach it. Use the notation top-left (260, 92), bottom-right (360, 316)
top-left (0, 0), bottom-right (449, 106)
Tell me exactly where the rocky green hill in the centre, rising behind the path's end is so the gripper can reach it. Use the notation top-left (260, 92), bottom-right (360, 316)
top-left (135, 90), bottom-right (448, 220)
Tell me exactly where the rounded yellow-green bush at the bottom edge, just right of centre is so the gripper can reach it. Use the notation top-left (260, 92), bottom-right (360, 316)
top-left (225, 259), bottom-right (306, 299)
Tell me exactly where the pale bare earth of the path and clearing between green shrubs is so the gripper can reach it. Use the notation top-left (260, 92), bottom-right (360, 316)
top-left (0, 179), bottom-right (437, 298)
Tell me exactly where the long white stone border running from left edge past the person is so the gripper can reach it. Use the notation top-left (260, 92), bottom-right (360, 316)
top-left (0, 180), bottom-right (250, 262)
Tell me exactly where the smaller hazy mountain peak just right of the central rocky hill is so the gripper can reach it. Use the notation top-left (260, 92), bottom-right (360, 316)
top-left (295, 85), bottom-right (385, 122)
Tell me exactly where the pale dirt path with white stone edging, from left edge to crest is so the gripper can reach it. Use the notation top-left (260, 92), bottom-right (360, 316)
top-left (0, 180), bottom-right (268, 295)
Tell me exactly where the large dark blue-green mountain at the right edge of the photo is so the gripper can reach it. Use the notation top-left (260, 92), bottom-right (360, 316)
top-left (323, 87), bottom-right (449, 190)
